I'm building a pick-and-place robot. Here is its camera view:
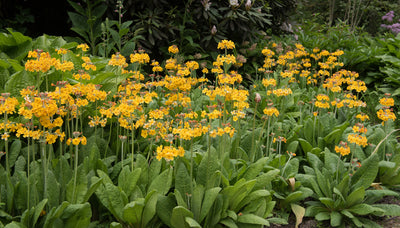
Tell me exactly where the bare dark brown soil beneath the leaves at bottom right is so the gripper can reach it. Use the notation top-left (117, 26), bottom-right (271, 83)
top-left (270, 196), bottom-right (400, 228)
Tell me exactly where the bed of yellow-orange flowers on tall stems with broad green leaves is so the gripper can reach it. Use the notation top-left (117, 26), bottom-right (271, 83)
top-left (0, 25), bottom-right (400, 227)
